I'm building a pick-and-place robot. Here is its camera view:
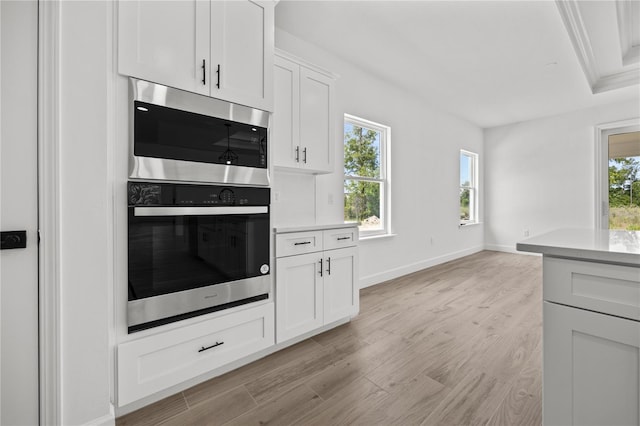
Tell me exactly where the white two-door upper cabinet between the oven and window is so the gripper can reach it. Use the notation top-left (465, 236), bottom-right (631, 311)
top-left (271, 52), bottom-right (335, 173)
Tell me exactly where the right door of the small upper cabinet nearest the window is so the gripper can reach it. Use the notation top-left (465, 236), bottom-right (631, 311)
top-left (300, 67), bottom-right (333, 172)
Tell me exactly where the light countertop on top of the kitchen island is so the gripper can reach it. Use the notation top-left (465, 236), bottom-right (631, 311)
top-left (516, 229), bottom-right (640, 266)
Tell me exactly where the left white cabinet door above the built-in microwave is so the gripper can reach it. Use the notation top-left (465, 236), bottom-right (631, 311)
top-left (118, 0), bottom-right (209, 95)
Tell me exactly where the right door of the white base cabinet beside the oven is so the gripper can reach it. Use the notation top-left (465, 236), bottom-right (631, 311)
top-left (323, 247), bottom-right (360, 324)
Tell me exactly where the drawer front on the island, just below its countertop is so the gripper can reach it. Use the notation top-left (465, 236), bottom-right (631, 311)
top-left (543, 257), bottom-right (640, 320)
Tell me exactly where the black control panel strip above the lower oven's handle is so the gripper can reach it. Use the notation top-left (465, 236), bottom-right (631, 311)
top-left (128, 182), bottom-right (271, 206)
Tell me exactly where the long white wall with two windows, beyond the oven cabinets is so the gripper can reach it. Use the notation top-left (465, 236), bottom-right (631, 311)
top-left (273, 29), bottom-right (483, 286)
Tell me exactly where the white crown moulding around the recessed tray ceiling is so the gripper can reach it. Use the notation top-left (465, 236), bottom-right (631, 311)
top-left (556, 0), bottom-right (640, 94)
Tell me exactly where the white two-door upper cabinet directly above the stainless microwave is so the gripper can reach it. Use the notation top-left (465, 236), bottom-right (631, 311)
top-left (118, 0), bottom-right (274, 111)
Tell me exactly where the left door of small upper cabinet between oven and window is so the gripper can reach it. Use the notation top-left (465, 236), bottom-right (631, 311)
top-left (271, 56), bottom-right (300, 168)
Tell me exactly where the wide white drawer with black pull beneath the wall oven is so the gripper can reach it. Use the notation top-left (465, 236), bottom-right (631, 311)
top-left (118, 303), bottom-right (275, 406)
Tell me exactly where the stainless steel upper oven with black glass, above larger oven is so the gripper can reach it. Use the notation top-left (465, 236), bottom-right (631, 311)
top-left (129, 79), bottom-right (269, 185)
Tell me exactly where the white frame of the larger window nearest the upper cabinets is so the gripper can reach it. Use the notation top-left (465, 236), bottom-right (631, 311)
top-left (342, 113), bottom-right (391, 239)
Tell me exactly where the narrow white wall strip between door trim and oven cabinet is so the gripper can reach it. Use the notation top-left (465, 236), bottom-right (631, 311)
top-left (58, 1), bottom-right (113, 425)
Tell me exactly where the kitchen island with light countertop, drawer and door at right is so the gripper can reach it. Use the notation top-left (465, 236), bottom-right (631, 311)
top-left (517, 229), bottom-right (640, 425)
